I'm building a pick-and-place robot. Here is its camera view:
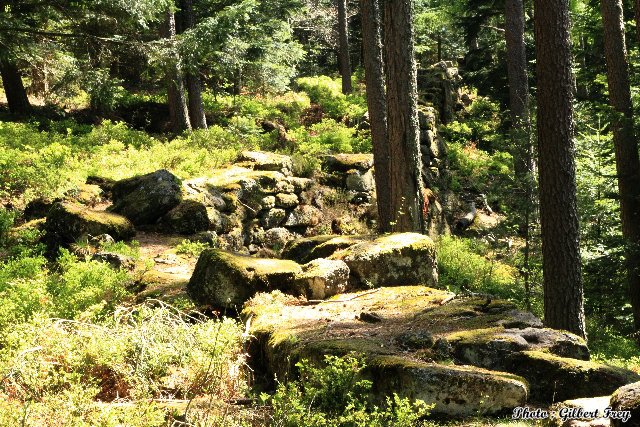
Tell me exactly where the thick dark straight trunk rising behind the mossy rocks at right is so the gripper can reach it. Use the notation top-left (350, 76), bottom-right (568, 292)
top-left (534, 0), bottom-right (586, 337)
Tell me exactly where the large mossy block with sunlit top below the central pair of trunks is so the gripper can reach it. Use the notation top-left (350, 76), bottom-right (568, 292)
top-left (331, 233), bottom-right (438, 287)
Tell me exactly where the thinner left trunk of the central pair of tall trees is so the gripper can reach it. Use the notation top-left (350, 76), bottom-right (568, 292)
top-left (360, 0), bottom-right (392, 232)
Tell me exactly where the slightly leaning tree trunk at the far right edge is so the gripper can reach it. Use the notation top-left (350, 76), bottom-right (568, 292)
top-left (600, 0), bottom-right (640, 331)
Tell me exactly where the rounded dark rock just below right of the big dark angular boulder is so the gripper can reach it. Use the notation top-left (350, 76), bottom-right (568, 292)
top-left (159, 200), bottom-right (210, 234)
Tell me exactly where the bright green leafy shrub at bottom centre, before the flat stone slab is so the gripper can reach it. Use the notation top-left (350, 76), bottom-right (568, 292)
top-left (263, 355), bottom-right (433, 427)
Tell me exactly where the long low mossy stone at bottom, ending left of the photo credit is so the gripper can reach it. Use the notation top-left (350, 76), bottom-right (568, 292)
top-left (367, 356), bottom-right (528, 417)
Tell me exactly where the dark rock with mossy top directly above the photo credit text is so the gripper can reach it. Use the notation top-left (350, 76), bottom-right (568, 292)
top-left (505, 351), bottom-right (640, 402)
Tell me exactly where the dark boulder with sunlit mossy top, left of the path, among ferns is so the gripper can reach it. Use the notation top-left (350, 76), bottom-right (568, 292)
top-left (44, 203), bottom-right (136, 250)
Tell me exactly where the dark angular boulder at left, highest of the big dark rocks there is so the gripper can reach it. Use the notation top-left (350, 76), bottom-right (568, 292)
top-left (110, 169), bottom-right (182, 225)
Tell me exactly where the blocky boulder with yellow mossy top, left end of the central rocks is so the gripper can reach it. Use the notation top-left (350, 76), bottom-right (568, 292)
top-left (187, 249), bottom-right (302, 308)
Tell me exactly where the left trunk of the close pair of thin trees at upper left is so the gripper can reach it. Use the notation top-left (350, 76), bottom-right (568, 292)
top-left (160, 11), bottom-right (191, 132)
